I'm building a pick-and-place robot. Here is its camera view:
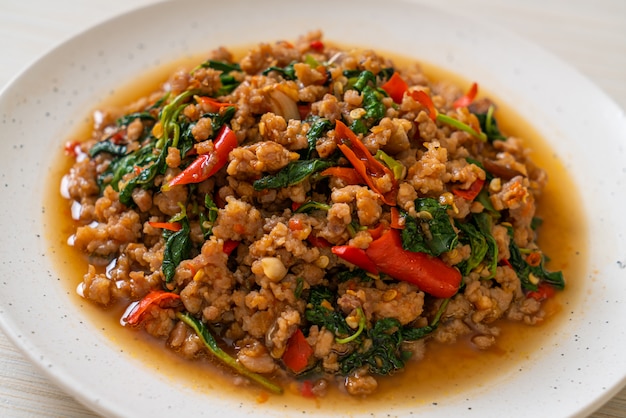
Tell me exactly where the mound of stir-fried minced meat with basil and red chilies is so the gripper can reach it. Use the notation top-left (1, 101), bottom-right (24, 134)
top-left (64, 32), bottom-right (564, 396)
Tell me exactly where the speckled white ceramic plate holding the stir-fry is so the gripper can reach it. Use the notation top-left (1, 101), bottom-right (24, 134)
top-left (0, 0), bottom-right (626, 417)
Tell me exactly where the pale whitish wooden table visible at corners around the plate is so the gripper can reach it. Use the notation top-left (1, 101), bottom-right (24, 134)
top-left (0, 0), bottom-right (626, 418)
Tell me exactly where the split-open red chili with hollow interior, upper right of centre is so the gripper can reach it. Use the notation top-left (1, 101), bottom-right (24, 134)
top-left (335, 120), bottom-right (398, 206)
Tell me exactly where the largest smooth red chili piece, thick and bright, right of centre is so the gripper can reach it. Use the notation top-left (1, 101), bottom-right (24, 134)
top-left (365, 229), bottom-right (461, 298)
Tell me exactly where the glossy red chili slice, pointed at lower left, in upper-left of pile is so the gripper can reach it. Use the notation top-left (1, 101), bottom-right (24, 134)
top-left (164, 125), bottom-right (238, 190)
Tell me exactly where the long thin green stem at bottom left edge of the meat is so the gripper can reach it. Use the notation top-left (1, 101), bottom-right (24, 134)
top-left (176, 312), bottom-right (283, 394)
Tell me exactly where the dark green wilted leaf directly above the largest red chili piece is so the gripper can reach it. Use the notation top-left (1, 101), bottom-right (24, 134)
top-left (402, 197), bottom-right (458, 257)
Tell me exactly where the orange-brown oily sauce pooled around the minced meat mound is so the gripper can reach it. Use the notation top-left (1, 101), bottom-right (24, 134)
top-left (45, 48), bottom-right (587, 414)
